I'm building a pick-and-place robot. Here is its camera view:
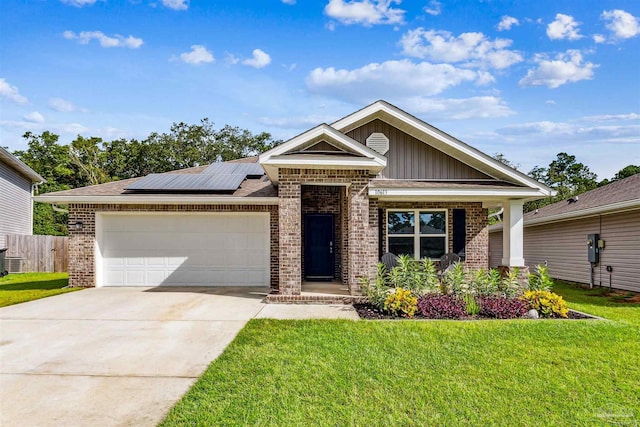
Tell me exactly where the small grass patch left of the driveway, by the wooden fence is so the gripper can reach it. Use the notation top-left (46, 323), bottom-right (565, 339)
top-left (0, 273), bottom-right (78, 307)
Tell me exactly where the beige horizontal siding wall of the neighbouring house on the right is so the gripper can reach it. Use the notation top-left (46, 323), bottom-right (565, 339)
top-left (489, 210), bottom-right (640, 292)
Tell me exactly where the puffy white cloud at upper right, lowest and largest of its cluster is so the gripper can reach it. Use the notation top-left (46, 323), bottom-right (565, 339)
top-left (519, 50), bottom-right (598, 89)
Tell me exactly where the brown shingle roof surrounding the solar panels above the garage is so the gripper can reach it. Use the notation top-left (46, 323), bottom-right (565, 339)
top-left (41, 156), bottom-right (278, 197)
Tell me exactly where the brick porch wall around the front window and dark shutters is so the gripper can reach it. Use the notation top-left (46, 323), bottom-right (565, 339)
top-left (379, 202), bottom-right (489, 270)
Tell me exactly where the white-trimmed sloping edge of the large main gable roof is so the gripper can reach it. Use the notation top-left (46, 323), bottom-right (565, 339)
top-left (331, 100), bottom-right (555, 196)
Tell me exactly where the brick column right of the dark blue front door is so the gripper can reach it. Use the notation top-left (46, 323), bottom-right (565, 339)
top-left (347, 176), bottom-right (378, 295)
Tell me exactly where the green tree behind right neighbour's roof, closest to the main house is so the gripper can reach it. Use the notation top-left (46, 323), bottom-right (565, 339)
top-left (525, 153), bottom-right (597, 212)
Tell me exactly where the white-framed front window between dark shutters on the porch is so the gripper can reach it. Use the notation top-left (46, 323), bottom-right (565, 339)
top-left (387, 210), bottom-right (447, 259)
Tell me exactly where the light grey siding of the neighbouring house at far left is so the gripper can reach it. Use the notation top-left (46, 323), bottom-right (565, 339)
top-left (0, 162), bottom-right (33, 249)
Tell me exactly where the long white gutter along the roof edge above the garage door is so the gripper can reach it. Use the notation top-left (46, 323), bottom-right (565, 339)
top-left (33, 195), bottom-right (278, 205)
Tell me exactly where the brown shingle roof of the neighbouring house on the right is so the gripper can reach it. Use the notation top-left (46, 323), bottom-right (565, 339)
top-left (524, 174), bottom-right (640, 223)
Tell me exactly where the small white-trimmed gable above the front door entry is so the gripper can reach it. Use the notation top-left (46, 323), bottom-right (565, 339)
top-left (259, 123), bottom-right (387, 184)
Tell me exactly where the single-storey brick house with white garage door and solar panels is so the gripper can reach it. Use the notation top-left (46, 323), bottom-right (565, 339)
top-left (36, 101), bottom-right (553, 300)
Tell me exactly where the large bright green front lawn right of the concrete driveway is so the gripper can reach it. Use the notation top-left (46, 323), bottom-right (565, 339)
top-left (162, 284), bottom-right (640, 426)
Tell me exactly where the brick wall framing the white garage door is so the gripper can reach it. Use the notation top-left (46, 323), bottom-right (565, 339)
top-left (68, 204), bottom-right (280, 288)
